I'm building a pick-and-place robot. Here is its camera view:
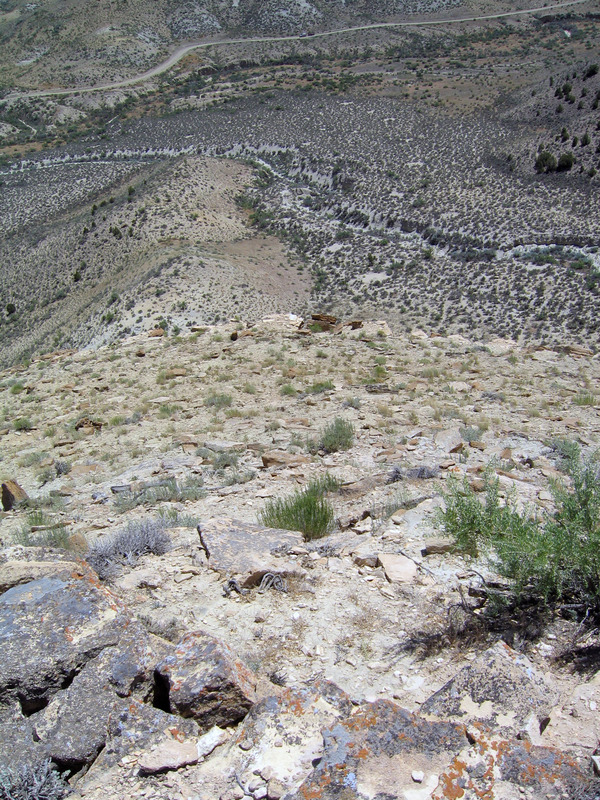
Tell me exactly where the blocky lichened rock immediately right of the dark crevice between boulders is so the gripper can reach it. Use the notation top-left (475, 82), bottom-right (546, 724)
top-left (156, 632), bottom-right (256, 730)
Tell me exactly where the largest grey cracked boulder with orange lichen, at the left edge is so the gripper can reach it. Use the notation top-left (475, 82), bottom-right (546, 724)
top-left (0, 562), bottom-right (164, 770)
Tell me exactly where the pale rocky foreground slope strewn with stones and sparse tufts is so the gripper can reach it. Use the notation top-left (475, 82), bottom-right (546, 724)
top-left (0, 315), bottom-right (600, 800)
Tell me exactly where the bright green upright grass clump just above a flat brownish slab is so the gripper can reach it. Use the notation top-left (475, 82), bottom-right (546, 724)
top-left (259, 475), bottom-right (339, 539)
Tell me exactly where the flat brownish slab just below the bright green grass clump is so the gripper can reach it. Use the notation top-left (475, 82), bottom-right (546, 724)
top-left (198, 517), bottom-right (304, 588)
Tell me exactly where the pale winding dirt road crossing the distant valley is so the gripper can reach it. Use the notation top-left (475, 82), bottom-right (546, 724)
top-left (13, 0), bottom-right (589, 98)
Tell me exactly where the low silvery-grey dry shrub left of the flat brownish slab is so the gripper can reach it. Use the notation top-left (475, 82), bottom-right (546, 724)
top-left (87, 517), bottom-right (171, 580)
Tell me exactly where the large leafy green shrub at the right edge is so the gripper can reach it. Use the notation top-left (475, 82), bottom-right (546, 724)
top-left (441, 444), bottom-right (600, 619)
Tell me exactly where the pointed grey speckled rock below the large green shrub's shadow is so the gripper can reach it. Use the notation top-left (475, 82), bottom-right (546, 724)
top-left (421, 642), bottom-right (559, 736)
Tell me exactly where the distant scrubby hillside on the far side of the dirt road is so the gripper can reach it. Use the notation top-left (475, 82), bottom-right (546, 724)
top-left (0, 0), bottom-right (461, 87)
